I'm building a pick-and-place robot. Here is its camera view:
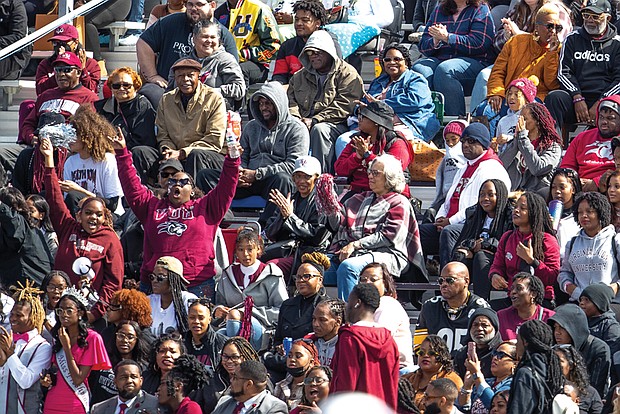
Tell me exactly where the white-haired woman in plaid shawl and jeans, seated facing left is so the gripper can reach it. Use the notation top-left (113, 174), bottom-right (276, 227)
top-left (326, 154), bottom-right (426, 300)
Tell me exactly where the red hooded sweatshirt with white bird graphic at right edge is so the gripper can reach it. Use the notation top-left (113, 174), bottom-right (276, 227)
top-left (560, 96), bottom-right (620, 185)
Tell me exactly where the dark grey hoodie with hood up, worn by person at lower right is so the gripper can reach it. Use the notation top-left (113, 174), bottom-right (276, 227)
top-left (548, 303), bottom-right (611, 397)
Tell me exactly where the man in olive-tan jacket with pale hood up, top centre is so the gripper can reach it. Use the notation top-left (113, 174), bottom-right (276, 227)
top-left (287, 30), bottom-right (364, 172)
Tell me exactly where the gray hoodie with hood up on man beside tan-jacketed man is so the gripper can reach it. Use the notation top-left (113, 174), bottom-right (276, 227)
top-left (240, 82), bottom-right (310, 179)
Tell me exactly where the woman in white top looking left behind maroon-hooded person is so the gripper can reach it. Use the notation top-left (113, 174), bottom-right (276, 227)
top-left (360, 262), bottom-right (414, 374)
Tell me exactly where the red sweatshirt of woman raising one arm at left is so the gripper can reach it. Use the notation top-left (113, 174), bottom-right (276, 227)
top-left (45, 168), bottom-right (125, 319)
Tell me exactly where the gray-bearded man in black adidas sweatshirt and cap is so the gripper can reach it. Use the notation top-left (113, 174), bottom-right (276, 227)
top-left (545, 0), bottom-right (620, 134)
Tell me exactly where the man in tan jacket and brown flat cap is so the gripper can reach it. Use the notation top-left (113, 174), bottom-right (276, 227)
top-left (155, 59), bottom-right (226, 178)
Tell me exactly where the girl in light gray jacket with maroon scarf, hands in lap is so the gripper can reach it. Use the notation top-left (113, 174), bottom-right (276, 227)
top-left (213, 227), bottom-right (288, 351)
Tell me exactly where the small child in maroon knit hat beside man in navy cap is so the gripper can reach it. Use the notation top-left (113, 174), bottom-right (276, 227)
top-left (431, 119), bottom-right (469, 210)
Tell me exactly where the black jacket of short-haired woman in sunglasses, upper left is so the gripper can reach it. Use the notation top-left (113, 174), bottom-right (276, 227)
top-left (94, 94), bottom-right (157, 150)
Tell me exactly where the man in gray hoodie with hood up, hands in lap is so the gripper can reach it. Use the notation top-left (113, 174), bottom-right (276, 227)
top-left (196, 82), bottom-right (308, 226)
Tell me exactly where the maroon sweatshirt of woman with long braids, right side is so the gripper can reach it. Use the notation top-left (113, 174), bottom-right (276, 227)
top-left (489, 230), bottom-right (560, 299)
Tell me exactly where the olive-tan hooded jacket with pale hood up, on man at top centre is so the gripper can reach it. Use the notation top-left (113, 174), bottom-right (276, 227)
top-left (287, 30), bottom-right (364, 123)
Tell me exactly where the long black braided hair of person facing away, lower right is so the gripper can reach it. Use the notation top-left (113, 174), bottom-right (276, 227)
top-left (517, 319), bottom-right (564, 395)
